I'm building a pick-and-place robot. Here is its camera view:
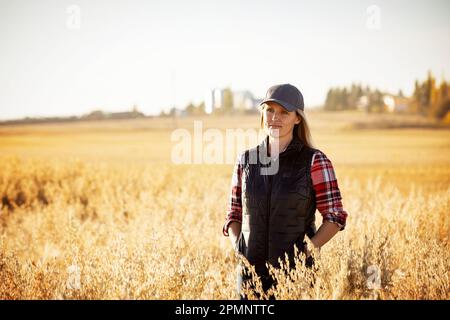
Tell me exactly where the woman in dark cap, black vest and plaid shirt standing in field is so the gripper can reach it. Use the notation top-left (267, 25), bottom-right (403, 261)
top-left (223, 84), bottom-right (347, 299)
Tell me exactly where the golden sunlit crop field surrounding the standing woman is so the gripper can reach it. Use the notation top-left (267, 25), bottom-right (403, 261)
top-left (0, 112), bottom-right (450, 299)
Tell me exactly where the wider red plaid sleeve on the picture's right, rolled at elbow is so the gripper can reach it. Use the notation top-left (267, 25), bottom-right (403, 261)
top-left (311, 150), bottom-right (348, 230)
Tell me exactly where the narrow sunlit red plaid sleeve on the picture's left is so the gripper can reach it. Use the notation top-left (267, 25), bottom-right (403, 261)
top-left (222, 156), bottom-right (242, 237)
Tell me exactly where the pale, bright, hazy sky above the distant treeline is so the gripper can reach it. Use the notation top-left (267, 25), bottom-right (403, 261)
top-left (0, 0), bottom-right (450, 120)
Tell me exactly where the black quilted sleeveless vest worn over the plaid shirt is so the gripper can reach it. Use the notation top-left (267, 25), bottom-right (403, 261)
top-left (239, 135), bottom-right (316, 276)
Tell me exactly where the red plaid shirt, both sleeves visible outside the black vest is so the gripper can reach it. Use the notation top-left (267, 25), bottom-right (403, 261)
top-left (223, 150), bottom-right (347, 236)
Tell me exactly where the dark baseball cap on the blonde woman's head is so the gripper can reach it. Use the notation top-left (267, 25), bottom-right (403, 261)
top-left (259, 83), bottom-right (305, 111)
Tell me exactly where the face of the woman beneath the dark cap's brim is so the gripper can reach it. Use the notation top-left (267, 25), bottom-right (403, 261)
top-left (263, 102), bottom-right (301, 138)
